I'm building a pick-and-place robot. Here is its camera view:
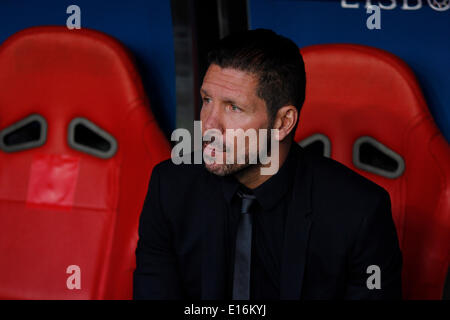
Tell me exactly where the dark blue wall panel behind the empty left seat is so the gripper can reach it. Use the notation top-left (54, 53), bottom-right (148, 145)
top-left (0, 0), bottom-right (175, 133)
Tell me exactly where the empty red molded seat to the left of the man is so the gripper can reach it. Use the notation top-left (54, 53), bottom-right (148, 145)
top-left (0, 27), bottom-right (170, 299)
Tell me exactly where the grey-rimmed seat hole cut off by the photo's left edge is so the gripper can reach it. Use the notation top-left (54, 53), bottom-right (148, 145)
top-left (0, 114), bottom-right (47, 152)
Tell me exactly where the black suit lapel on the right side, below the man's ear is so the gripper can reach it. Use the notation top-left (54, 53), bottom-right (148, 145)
top-left (280, 146), bottom-right (312, 300)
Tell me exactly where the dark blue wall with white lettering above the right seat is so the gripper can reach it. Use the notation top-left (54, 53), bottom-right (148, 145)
top-left (249, 0), bottom-right (450, 141)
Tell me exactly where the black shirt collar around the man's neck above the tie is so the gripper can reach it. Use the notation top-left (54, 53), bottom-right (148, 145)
top-left (221, 142), bottom-right (296, 210)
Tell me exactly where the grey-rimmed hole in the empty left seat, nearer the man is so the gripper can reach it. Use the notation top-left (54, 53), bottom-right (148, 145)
top-left (68, 118), bottom-right (117, 159)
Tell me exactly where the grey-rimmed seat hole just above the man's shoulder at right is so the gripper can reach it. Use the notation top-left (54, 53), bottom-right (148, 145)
top-left (353, 136), bottom-right (405, 178)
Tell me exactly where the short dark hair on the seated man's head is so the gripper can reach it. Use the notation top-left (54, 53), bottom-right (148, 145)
top-left (208, 29), bottom-right (306, 132)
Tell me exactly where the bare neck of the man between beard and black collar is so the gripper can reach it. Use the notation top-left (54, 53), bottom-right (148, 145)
top-left (235, 141), bottom-right (292, 189)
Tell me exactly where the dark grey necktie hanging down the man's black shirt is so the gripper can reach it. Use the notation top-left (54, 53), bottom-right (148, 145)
top-left (233, 191), bottom-right (255, 300)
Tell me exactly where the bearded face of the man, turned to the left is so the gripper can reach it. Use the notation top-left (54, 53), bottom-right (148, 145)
top-left (200, 64), bottom-right (270, 176)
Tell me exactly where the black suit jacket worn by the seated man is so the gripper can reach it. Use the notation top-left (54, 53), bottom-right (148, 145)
top-left (134, 144), bottom-right (402, 300)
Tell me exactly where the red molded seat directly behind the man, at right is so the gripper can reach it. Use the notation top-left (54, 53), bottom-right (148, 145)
top-left (295, 44), bottom-right (450, 299)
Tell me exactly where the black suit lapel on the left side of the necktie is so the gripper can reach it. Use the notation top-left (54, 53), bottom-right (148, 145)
top-left (201, 174), bottom-right (227, 300)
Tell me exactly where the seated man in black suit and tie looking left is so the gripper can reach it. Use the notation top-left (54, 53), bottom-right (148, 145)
top-left (134, 29), bottom-right (402, 300)
